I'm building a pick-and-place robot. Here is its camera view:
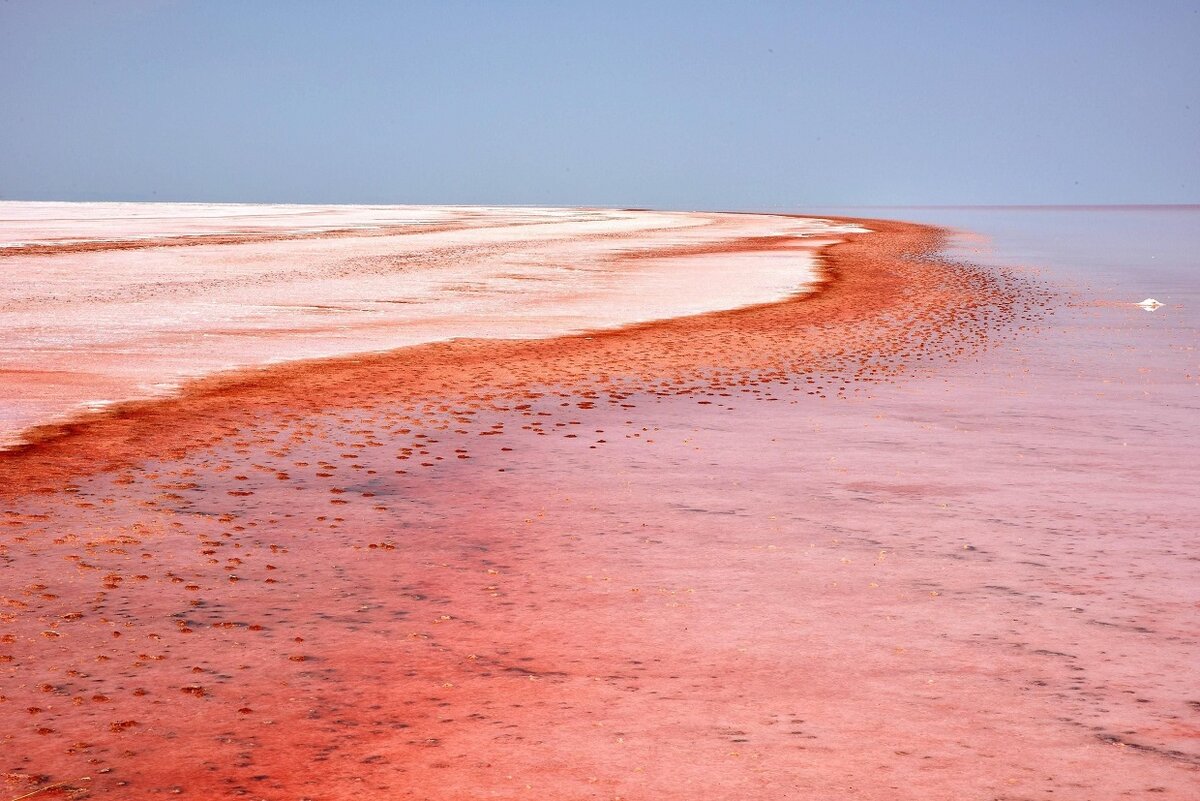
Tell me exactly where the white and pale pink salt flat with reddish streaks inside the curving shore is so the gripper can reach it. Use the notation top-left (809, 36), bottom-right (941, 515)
top-left (0, 203), bottom-right (862, 446)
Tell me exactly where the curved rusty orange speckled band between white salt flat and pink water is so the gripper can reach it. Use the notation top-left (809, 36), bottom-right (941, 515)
top-left (0, 218), bottom-right (1033, 494)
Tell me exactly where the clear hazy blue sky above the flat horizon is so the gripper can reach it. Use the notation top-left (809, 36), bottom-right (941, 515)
top-left (0, 0), bottom-right (1200, 210)
